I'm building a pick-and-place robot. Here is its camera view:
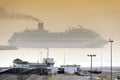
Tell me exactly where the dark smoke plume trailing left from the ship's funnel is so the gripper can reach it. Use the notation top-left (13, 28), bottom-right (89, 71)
top-left (0, 7), bottom-right (41, 22)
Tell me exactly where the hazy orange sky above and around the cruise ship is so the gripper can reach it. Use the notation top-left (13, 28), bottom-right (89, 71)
top-left (0, 0), bottom-right (120, 66)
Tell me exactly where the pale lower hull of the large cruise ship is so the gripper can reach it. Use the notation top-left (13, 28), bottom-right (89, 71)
top-left (10, 40), bottom-right (107, 48)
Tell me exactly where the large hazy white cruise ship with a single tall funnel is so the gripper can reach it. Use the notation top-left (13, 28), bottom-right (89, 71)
top-left (8, 23), bottom-right (108, 48)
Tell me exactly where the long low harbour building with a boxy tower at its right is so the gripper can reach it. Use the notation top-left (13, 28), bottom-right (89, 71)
top-left (13, 58), bottom-right (58, 73)
